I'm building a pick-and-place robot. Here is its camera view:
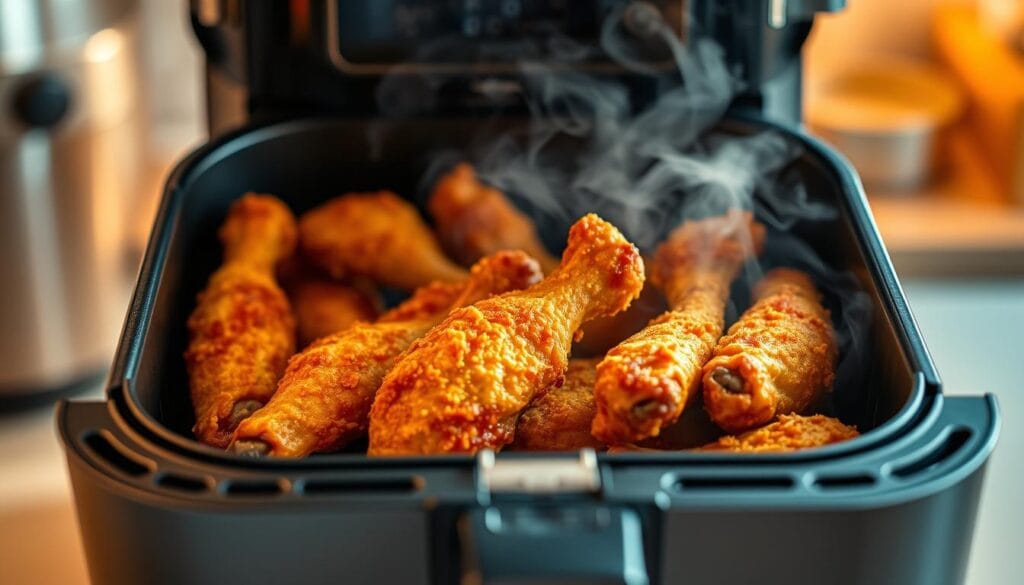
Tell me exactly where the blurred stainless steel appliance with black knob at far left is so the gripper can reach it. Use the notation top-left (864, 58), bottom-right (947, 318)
top-left (0, 0), bottom-right (140, 401)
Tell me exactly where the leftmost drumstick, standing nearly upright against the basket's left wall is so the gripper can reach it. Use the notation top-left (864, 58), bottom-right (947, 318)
top-left (184, 195), bottom-right (296, 448)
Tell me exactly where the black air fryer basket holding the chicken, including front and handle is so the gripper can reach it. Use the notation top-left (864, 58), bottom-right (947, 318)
top-left (58, 119), bottom-right (998, 584)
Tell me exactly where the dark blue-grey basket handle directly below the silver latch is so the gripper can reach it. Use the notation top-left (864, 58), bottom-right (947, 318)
top-left (459, 504), bottom-right (648, 585)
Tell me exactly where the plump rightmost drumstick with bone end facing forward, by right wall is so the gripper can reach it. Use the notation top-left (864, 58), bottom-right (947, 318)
top-left (703, 268), bottom-right (838, 432)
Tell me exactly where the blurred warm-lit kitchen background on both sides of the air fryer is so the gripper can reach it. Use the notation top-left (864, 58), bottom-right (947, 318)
top-left (0, 0), bottom-right (1024, 585)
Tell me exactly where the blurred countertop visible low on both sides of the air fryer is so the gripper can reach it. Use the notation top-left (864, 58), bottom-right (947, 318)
top-left (0, 279), bottom-right (1024, 585)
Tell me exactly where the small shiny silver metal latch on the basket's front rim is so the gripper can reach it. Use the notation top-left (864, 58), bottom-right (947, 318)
top-left (476, 449), bottom-right (601, 494)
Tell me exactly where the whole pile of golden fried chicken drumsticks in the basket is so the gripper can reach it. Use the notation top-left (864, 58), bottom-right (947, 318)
top-left (185, 164), bottom-right (857, 457)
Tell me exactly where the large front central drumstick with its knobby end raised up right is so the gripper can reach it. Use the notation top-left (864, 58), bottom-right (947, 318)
top-left (370, 214), bottom-right (644, 455)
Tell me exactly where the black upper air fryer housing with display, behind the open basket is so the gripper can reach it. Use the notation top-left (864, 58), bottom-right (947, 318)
top-left (190, 0), bottom-right (845, 134)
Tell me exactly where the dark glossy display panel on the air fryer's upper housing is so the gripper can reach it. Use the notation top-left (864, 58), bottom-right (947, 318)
top-left (328, 0), bottom-right (686, 75)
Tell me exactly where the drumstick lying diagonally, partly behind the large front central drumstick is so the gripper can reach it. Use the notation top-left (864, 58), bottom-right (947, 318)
top-left (232, 251), bottom-right (541, 457)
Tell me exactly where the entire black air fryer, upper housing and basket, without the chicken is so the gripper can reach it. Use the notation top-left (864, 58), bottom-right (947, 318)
top-left (57, 0), bottom-right (999, 585)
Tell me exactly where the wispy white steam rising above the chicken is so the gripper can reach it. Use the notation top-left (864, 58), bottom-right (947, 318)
top-left (458, 9), bottom-right (834, 252)
